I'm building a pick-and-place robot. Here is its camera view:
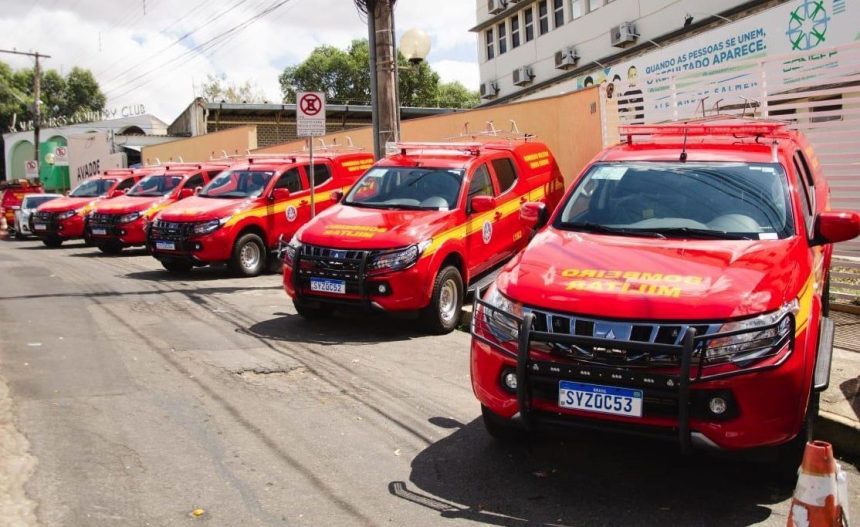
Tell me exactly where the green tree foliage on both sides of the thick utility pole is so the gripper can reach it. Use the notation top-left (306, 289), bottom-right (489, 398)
top-left (278, 39), bottom-right (480, 108)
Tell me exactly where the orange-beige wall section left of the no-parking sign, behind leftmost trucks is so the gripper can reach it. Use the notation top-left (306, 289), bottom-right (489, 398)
top-left (141, 126), bottom-right (257, 165)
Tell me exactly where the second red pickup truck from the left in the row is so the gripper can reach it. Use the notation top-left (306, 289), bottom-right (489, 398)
top-left (87, 163), bottom-right (223, 254)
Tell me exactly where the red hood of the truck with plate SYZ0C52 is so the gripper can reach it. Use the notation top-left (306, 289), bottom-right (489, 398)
top-left (299, 205), bottom-right (453, 249)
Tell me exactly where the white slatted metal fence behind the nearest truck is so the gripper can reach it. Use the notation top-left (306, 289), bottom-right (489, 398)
top-left (601, 42), bottom-right (860, 304)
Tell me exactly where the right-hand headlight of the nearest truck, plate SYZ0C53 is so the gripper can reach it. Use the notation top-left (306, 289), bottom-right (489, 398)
top-left (705, 300), bottom-right (799, 366)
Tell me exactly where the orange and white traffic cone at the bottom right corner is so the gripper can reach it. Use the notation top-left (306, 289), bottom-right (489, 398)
top-left (788, 441), bottom-right (848, 527)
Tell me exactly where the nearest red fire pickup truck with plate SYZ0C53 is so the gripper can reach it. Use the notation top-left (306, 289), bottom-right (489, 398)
top-left (471, 118), bottom-right (860, 471)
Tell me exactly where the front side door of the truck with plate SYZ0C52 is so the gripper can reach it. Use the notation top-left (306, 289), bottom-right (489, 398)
top-left (466, 163), bottom-right (499, 276)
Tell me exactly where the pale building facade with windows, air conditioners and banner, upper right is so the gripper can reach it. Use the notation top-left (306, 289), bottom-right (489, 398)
top-left (472, 0), bottom-right (820, 104)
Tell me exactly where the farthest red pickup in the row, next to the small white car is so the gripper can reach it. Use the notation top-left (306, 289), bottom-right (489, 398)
top-left (30, 170), bottom-right (146, 247)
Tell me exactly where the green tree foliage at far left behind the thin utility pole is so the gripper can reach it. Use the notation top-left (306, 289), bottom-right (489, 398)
top-left (0, 62), bottom-right (107, 131)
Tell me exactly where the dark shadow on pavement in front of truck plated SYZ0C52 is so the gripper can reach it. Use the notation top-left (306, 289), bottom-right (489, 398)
top-left (246, 313), bottom-right (424, 345)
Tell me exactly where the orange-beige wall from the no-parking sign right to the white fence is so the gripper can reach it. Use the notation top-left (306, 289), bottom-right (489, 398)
top-left (255, 88), bottom-right (602, 183)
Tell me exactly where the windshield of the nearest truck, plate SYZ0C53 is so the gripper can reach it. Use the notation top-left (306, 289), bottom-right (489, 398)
top-left (554, 162), bottom-right (794, 240)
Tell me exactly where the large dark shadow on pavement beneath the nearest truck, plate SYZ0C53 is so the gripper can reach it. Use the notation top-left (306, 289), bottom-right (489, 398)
top-left (388, 418), bottom-right (793, 526)
